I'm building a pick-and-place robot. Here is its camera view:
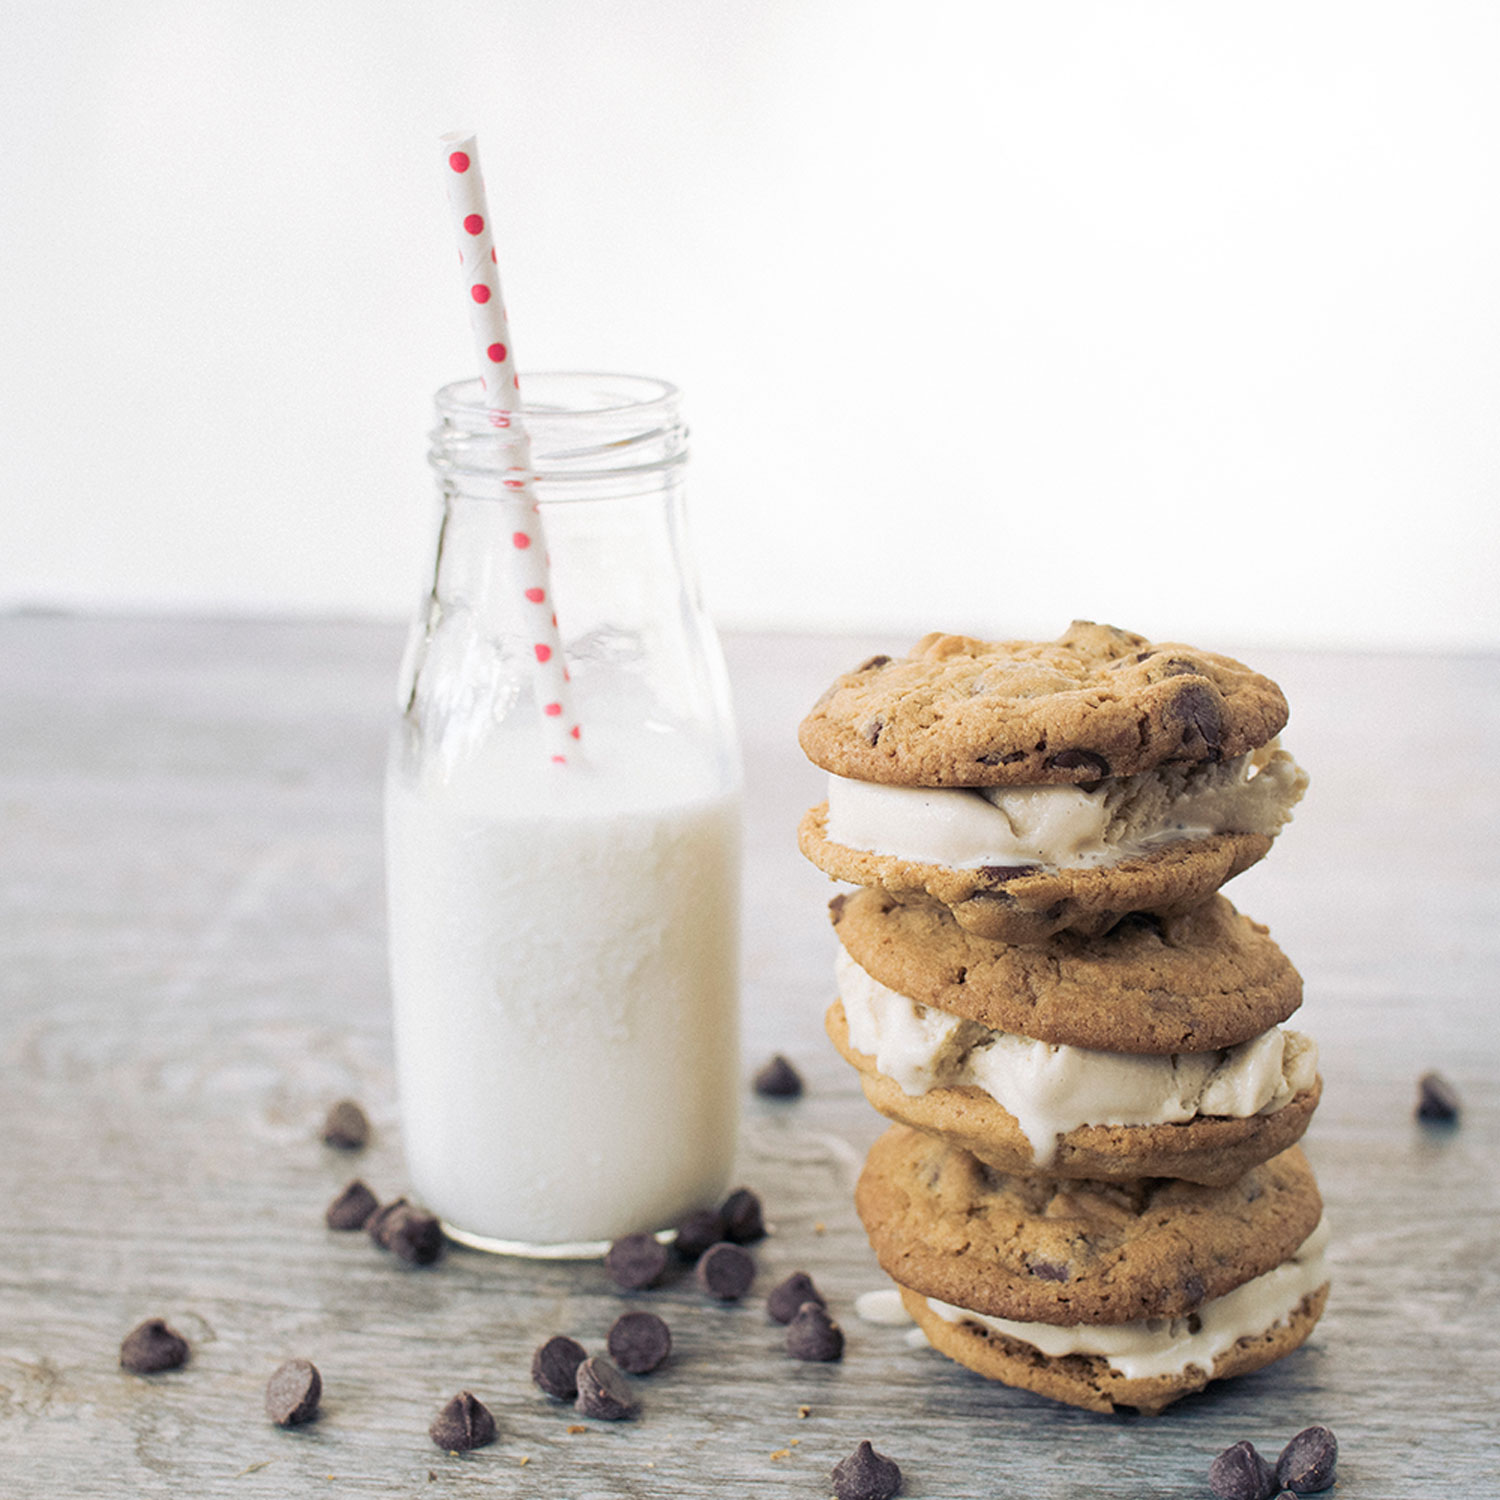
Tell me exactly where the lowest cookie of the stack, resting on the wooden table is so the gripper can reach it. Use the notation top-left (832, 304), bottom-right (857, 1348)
top-left (900, 1281), bottom-right (1328, 1416)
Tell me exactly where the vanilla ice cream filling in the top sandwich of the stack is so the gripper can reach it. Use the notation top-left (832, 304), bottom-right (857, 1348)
top-left (828, 746), bottom-right (1307, 870)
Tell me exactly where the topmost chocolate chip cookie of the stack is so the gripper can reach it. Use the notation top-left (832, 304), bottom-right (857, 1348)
top-left (798, 620), bottom-right (1287, 786)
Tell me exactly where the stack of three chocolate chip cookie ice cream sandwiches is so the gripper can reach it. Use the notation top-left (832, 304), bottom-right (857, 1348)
top-left (800, 621), bottom-right (1328, 1412)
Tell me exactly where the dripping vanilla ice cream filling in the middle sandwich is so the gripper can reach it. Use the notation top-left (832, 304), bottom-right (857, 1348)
top-left (836, 948), bottom-right (1317, 1167)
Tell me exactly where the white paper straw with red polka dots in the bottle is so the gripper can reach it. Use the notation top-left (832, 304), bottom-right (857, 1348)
top-left (443, 132), bottom-right (582, 765)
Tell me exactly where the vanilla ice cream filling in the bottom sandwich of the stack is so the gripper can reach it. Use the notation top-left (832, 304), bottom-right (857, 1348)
top-left (927, 1220), bottom-right (1328, 1380)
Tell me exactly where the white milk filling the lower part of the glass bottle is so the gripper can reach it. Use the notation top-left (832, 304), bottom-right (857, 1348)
top-left (386, 723), bottom-right (740, 1253)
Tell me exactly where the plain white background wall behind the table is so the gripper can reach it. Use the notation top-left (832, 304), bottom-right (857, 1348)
top-left (0, 0), bottom-right (1500, 648)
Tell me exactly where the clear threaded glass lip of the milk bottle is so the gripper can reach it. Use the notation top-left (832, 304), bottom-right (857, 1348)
top-left (429, 371), bottom-right (687, 489)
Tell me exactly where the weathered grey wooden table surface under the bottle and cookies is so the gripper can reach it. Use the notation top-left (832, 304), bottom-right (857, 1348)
top-left (0, 617), bottom-right (1500, 1500)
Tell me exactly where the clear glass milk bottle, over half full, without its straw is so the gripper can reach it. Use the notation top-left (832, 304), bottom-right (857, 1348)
top-left (386, 375), bottom-right (741, 1256)
